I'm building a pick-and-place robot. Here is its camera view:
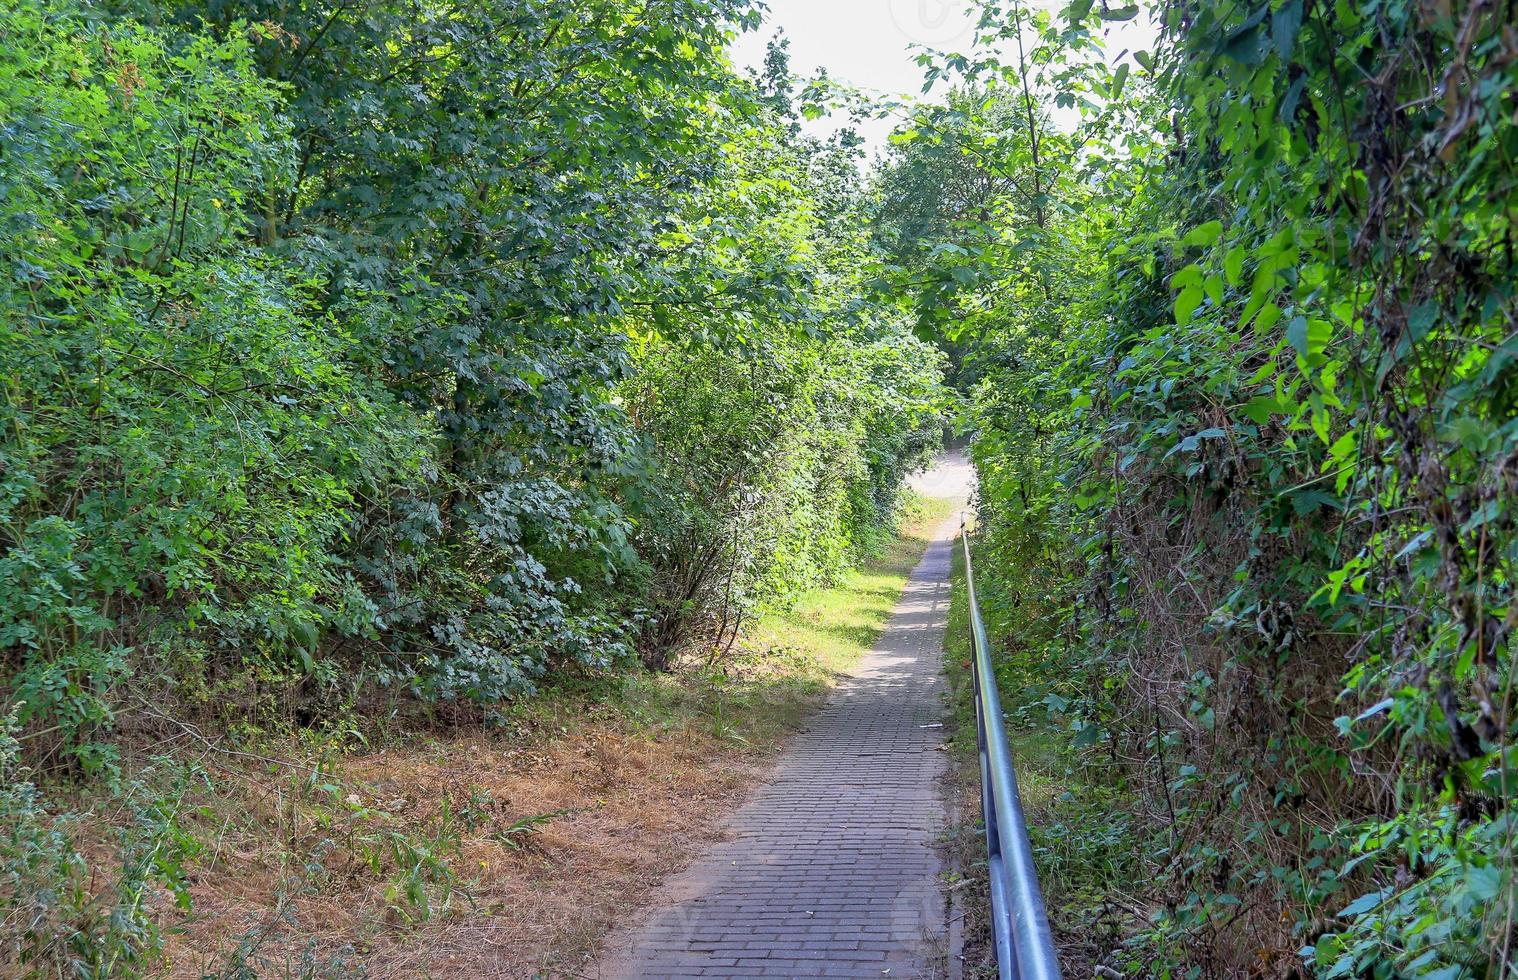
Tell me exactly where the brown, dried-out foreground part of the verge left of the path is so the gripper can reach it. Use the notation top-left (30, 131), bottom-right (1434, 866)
top-left (154, 679), bottom-right (812, 978)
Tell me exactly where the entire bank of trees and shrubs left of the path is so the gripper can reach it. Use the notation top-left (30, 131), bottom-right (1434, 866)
top-left (0, 0), bottom-right (941, 975)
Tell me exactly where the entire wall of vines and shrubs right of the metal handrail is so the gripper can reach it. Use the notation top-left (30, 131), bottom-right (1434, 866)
top-left (894, 0), bottom-right (1518, 978)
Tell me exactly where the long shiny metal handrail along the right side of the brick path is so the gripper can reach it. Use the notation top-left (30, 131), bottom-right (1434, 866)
top-left (959, 520), bottom-right (1060, 980)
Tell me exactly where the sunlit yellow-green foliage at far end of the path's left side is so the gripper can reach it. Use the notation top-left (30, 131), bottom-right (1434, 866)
top-left (622, 92), bottom-right (944, 666)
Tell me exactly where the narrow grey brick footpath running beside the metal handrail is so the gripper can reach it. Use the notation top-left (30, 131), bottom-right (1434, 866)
top-left (592, 454), bottom-right (970, 980)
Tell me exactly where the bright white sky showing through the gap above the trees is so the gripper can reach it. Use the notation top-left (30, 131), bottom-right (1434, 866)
top-left (733, 0), bottom-right (1155, 153)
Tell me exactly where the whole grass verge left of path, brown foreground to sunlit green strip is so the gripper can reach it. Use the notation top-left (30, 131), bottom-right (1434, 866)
top-left (93, 502), bottom-right (947, 978)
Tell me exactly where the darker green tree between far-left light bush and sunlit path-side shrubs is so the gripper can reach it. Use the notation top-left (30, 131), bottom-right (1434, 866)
top-left (175, 0), bottom-right (771, 701)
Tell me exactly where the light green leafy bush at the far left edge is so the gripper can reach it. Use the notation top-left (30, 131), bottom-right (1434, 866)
top-left (0, 5), bottom-right (422, 772)
